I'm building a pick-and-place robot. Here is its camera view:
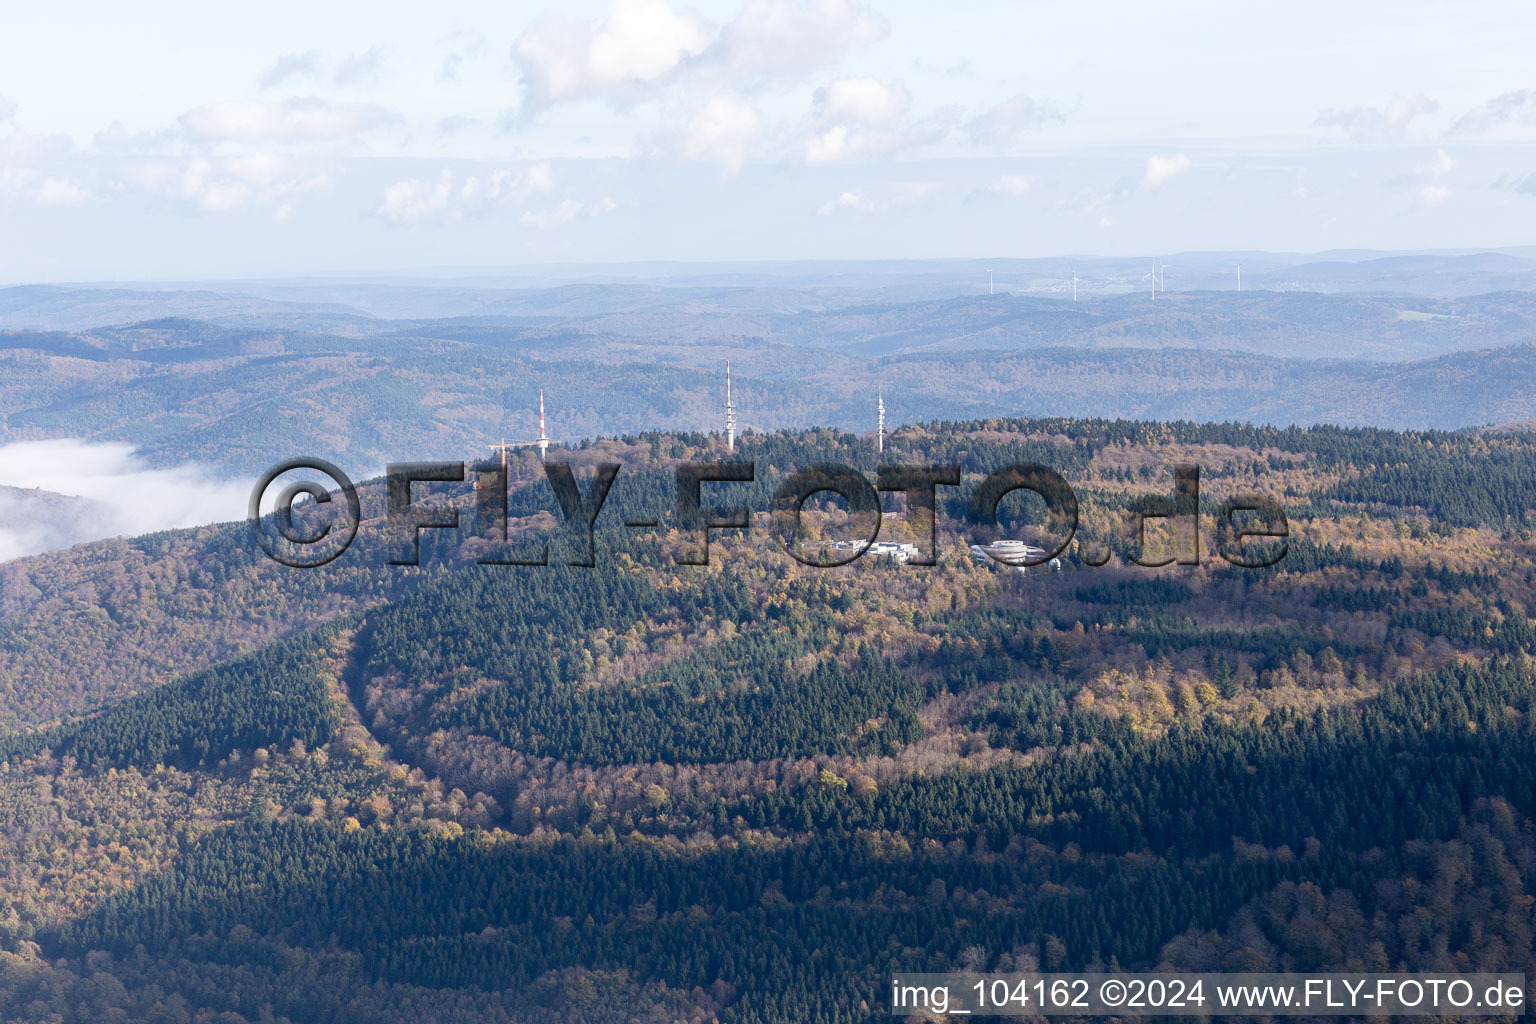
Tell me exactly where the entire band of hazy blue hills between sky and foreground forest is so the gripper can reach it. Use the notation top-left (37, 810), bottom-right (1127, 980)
top-left (0, 264), bottom-right (1536, 474)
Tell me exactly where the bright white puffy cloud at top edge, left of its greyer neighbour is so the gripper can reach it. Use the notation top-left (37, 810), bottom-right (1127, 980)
top-left (511, 0), bottom-right (710, 111)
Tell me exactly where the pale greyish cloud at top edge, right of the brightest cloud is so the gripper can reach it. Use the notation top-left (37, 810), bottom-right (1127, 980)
top-left (710, 0), bottom-right (889, 83)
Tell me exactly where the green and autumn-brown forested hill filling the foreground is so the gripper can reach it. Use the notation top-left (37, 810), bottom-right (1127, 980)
top-left (0, 419), bottom-right (1536, 1024)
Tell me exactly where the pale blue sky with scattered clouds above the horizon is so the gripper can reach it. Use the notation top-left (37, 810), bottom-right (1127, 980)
top-left (0, 0), bottom-right (1536, 284)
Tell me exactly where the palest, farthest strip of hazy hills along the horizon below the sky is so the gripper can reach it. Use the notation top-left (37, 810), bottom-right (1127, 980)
top-left (9, 252), bottom-right (1536, 340)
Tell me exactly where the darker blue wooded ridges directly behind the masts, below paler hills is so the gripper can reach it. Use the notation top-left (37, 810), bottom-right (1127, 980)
top-left (0, 317), bottom-right (1536, 473)
